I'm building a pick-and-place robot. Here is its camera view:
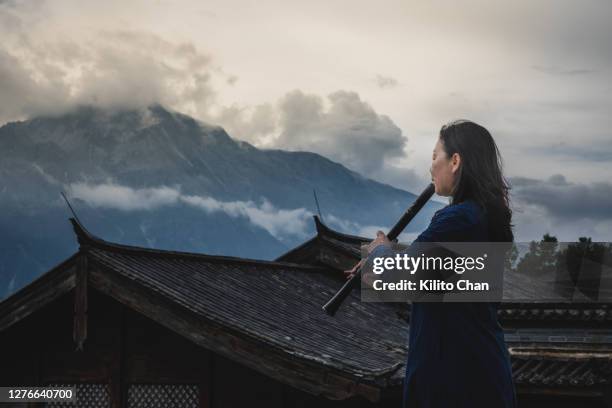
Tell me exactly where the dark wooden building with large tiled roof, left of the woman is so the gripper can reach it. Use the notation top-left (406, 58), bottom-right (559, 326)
top-left (0, 219), bottom-right (407, 408)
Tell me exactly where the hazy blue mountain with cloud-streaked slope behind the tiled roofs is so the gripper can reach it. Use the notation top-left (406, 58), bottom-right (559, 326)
top-left (0, 105), bottom-right (439, 297)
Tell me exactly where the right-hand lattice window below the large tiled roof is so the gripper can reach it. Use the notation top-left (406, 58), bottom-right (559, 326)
top-left (128, 384), bottom-right (200, 408)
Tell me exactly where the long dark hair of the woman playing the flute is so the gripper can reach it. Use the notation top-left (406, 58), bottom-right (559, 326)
top-left (440, 119), bottom-right (514, 242)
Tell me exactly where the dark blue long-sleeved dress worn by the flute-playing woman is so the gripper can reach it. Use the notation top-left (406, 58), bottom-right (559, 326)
top-left (368, 200), bottom-right (516, 408)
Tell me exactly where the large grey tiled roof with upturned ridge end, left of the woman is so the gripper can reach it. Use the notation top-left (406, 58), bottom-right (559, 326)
top-left (0, 219), bottom-right (408, 400)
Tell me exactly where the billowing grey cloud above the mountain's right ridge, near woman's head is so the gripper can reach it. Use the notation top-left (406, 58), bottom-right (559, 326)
top-left (214, 90), bottom-right (408, 183)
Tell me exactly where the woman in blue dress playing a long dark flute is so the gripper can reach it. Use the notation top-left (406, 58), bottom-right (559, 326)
top-left (346, 120), bottom-right (516, 408)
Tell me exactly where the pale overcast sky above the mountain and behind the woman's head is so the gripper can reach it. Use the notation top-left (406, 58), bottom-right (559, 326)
top-left (0, 0), bottom-right (612, 240)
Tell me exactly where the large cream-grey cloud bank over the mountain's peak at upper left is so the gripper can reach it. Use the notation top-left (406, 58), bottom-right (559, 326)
top-left (0, 7), bottom-right (220, 122)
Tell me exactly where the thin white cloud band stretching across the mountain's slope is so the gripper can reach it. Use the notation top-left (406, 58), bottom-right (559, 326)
top-left (67, 182), bottom-right (313, 240)
